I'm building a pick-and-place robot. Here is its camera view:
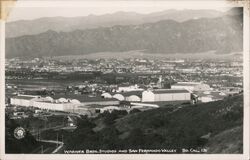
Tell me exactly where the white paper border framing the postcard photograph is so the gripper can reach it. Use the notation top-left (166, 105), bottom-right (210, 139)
top-left (0, 0), bottom-right (250, 160)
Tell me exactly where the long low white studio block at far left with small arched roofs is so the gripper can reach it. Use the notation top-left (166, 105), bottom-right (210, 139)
top-left (10, 95), bottom-right (120, 113)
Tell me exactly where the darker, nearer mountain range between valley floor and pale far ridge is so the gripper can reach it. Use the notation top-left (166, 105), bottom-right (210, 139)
top-left (6, 16), bottom-right (243, 58)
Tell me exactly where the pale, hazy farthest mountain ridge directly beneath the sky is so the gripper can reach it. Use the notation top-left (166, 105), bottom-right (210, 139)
top-left (6, 9), bottom-right (224, 37)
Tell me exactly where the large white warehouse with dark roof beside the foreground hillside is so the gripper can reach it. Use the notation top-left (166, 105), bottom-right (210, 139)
top-left (142, 89), bottom-right (191, 102)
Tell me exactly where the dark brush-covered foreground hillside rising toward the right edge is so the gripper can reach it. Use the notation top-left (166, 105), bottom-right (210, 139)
top-left (63, 95), bottom-right (243, 153)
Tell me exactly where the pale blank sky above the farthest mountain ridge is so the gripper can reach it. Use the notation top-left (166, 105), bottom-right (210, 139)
top-left (8, 1), bottom-right (234, 22)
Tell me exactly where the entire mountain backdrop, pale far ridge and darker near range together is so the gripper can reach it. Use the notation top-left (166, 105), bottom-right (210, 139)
top-left (6, 9), bottom-right (243, 58)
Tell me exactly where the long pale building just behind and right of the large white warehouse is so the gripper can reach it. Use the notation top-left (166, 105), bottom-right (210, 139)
top-left (171, 82), bottom-right (211, 92)
